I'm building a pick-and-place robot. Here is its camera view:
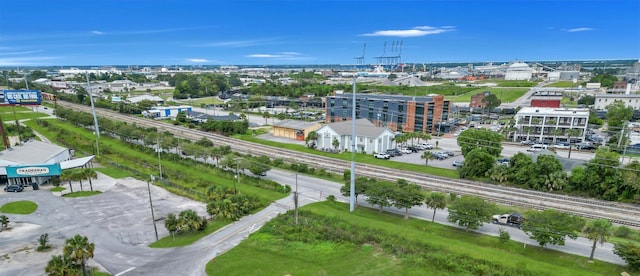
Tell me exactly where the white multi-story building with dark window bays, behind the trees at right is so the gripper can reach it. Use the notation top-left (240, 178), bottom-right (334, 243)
top-left (513, 107), bottom-right (589, 144)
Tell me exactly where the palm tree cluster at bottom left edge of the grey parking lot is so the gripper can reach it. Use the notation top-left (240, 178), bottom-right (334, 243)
top-left (45, 235), bottom-right (95, 276)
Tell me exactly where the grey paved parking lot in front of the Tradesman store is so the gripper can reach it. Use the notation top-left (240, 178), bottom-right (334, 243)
top-left (0, 173), bottom-right (206, 275)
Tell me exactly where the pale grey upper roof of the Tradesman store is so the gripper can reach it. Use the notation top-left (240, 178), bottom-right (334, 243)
top-left (0, 140), bottom-right (67, 166)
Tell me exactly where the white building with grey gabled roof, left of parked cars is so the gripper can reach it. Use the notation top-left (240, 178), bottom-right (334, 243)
top-left (316, 119), bottom-right (395, 154)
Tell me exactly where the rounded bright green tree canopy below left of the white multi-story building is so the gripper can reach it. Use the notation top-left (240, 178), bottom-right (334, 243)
top-left (458, 128), bottom-right (502, 157)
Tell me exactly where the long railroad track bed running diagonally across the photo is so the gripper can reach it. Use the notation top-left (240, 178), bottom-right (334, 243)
top-left (58, 102), bottom-right (640, 228)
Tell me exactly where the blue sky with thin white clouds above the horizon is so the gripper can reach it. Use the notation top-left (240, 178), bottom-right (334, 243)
top-left (0, 0), bottom-right (640, 66)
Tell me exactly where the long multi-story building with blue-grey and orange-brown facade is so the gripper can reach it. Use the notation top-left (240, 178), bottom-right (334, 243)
top-left (326, 93), bottom-right (450, 133)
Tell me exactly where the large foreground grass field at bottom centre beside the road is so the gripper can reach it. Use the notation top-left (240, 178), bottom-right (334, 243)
top-left (206, 202), bottom-right (624, 275)
